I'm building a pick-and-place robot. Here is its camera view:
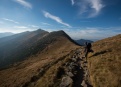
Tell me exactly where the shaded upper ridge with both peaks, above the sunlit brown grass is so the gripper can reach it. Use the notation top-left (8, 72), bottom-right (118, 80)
top-left (0, 29), bottom-right (77, 67)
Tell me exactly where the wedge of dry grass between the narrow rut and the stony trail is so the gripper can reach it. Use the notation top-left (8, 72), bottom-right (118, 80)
top-left (33, 50), bottom-right (75, 87)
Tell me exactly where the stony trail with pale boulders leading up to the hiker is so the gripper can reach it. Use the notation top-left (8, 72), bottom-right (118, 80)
top-left (60, 48), bottom-right (93, 87)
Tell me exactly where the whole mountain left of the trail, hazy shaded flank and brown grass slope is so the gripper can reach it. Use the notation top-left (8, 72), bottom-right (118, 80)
top-left (0, 30), bottom-right (79, 87)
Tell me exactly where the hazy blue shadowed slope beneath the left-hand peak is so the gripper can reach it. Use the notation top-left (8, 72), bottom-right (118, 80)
top-left (0, 29), bottom-right (48, 67)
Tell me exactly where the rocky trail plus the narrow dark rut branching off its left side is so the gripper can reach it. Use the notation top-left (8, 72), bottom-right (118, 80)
top-left (22, 48), bottom-right (93, 87)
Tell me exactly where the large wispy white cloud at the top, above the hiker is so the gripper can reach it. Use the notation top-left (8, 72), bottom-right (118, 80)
top-left (73, 0), bottom-right (105, 18)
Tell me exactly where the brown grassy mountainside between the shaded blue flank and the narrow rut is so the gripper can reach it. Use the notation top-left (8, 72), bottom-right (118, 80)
top-left (0, 37), bottom-right (78, 87)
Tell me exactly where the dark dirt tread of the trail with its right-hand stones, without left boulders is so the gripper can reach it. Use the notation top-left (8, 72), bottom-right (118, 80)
top-left (73, 48), bottom-right (92, 87)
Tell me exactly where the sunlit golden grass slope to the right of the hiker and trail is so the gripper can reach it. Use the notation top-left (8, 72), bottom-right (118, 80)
top-left (88, 34), bottom-right (121, 87)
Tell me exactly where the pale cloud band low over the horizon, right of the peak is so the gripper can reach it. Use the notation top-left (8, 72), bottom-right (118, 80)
top-left (65, 27), bottom-right (121, 40)
